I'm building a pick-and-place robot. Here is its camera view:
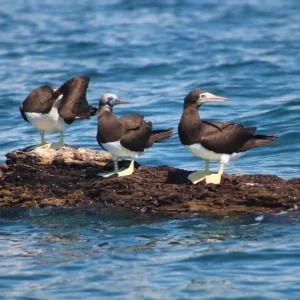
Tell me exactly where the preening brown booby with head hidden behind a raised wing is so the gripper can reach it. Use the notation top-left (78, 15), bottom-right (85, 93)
top-left (20, 76), bottom-right (97, 149)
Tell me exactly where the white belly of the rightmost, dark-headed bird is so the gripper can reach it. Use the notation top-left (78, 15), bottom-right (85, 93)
top-left (184, 144), bottom-right (245, 164)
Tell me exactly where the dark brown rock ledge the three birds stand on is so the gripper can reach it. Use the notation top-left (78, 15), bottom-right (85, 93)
top-left (0, 147), bottom-right (300, 215)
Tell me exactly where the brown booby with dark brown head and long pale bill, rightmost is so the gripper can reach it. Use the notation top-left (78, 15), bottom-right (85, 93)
top-left (178, 90), bottom-right (277, 184)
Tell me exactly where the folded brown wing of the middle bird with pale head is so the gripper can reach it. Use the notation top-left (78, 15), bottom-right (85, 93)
top-left (119, 114), bottom-right (152, 152)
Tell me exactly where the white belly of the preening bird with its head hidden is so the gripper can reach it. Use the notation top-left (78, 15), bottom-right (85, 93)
top-left (25, 106), bottom-right (68, 132)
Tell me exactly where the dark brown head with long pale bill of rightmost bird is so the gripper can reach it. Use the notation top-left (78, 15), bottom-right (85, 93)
top-left (184, 90), bottom-right (229, 107)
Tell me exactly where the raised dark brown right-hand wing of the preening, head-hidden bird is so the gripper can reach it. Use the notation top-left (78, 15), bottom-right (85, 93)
top-left (58, 76), bottom-right (91, 124)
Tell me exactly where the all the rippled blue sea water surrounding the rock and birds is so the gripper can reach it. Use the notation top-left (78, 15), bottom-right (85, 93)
top-left (0, 0), bottom-right (300, 299)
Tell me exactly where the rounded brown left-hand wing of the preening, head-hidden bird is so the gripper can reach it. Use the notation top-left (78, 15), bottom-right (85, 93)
top-left (20, 85), bottom-right (55, 122)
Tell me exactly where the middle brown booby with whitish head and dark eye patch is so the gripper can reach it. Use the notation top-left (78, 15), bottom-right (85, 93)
top-left (97, 93), bottom-right (173, 177)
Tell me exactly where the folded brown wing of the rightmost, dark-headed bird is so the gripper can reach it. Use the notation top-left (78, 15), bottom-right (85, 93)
top-left (200, 121), bottom-right (256, 154)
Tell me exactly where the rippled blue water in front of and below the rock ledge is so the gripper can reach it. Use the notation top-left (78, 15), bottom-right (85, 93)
top-left (0, 206), bottom-right (300, 299)
